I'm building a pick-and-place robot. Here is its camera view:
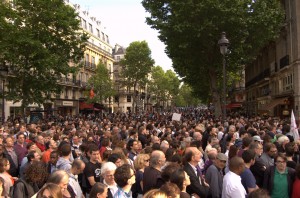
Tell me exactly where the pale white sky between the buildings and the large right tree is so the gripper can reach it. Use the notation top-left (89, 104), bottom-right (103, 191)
top-left (70, 0), bottom-right (173, 71)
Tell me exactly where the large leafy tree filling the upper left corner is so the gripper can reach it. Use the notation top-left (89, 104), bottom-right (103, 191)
top-left (0, 0), bottom-right (87, 107)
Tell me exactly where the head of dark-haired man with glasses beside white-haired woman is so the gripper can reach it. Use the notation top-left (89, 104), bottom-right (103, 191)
top-left (115, 164), bottom-right (135, 188)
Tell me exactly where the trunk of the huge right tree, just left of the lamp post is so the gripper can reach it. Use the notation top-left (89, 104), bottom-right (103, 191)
top-left (209, 69), bottom-right (222, 117)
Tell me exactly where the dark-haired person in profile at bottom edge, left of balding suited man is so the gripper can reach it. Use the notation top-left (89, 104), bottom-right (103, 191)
top-left (170, 168), bottom-right (191, 198)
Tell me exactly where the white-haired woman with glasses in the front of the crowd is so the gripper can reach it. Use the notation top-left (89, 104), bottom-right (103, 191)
top-left (101, 162), bottom-right (118, 197)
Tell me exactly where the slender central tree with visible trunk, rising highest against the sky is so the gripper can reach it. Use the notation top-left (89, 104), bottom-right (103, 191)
top-left (120, 41), bottom-right (154, 111)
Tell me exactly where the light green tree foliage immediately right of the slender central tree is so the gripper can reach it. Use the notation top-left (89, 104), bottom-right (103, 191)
top-left (148, 66), bottom-right (180, 102)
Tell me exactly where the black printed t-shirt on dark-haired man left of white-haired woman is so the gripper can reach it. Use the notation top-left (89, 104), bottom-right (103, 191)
top-left (84, 162), bottom-right (101, 192)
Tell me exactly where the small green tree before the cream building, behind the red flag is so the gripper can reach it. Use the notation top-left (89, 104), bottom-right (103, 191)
top-left (88, 63), bottom-right (116, 104)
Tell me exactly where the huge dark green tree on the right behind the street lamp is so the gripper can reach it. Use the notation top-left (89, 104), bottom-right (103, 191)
top-left (142, 0), bottom-right (284, 116)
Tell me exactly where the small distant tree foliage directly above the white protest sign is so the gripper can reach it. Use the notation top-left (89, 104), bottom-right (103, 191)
top-left (175, 84), bottom-right (201, 107)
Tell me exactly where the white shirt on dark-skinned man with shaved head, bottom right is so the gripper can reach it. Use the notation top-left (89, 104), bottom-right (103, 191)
top-left (222, 171), bottom-right (246, 198)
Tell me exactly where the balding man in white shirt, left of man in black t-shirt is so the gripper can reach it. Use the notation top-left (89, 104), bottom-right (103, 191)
top-left (69, 159), bottom-right (85, 198)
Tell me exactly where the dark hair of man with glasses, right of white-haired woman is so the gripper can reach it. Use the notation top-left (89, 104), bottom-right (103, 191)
top-left (114, 164), bottom-right (132, 188)
